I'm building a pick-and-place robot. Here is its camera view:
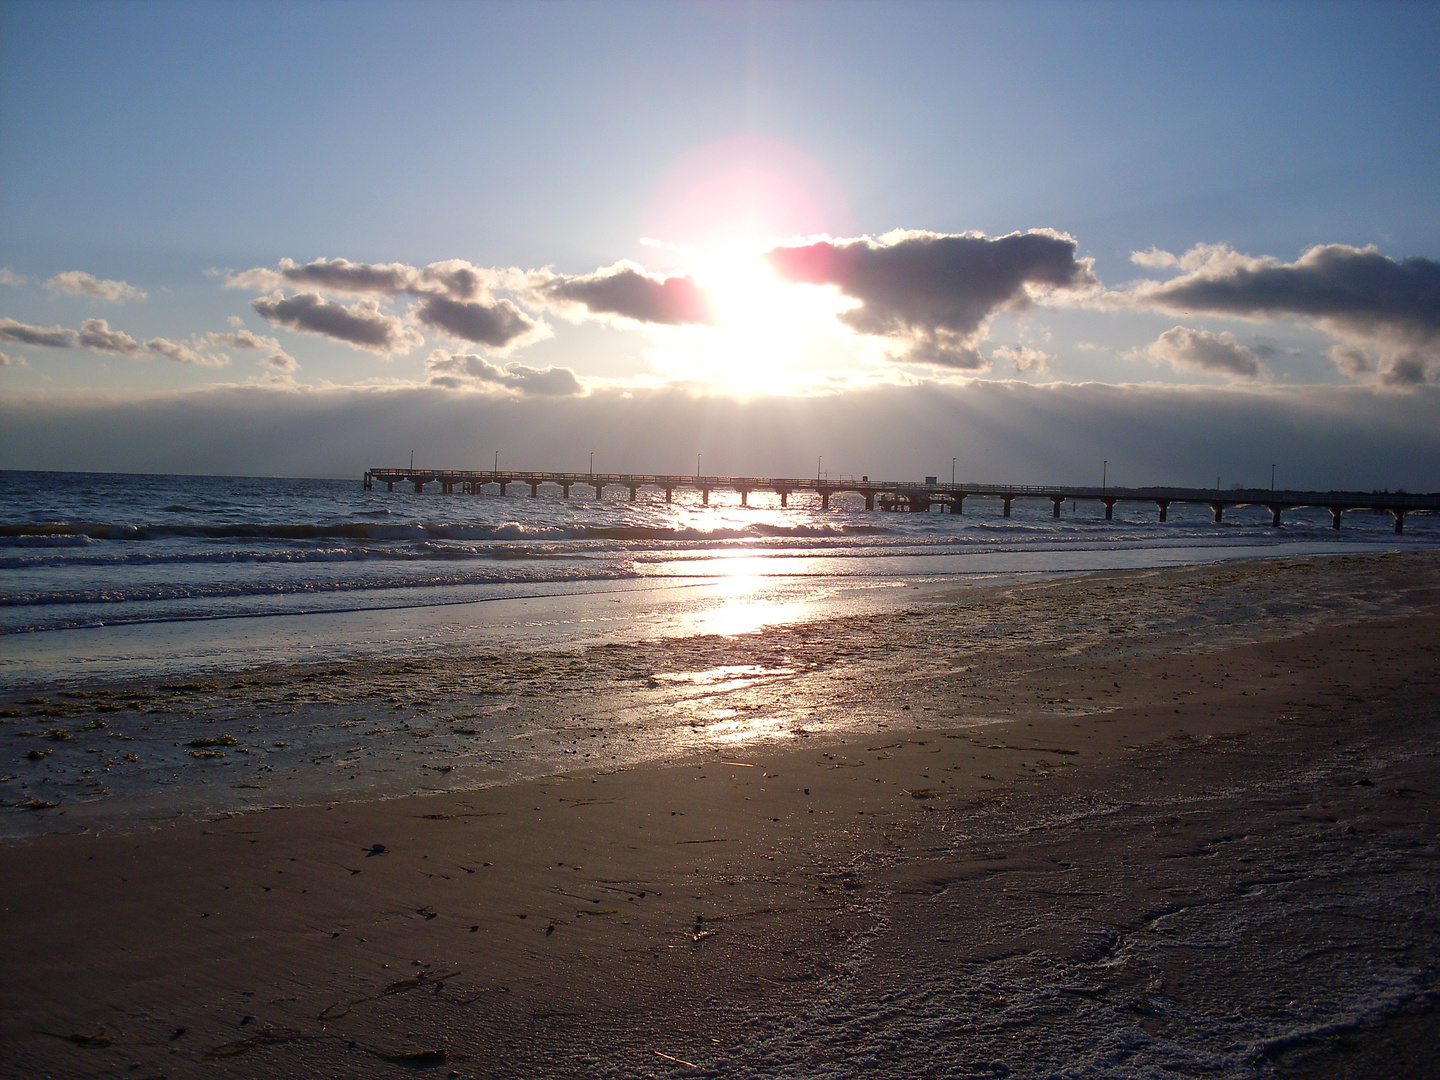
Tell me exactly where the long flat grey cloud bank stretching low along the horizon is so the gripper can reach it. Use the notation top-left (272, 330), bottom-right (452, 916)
top-left (0, 377), bottom-right (1440, 491)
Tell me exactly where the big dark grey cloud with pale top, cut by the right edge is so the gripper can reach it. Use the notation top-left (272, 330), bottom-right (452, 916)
top-left (1119, 243), bottom-right (1440, 386)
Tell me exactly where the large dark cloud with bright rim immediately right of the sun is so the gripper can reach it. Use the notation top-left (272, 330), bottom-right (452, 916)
top-left (766, 229), bottom-right (1097, 370)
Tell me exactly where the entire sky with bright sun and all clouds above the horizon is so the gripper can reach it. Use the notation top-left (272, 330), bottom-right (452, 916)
top-left (0, 0), bottom-right (1440, 491)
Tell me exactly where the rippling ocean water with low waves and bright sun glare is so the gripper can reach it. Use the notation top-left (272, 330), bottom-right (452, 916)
top-left (0, 472), bottom-right (1440, 681)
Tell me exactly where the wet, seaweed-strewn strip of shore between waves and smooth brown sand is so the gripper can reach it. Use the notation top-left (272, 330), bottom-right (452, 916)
top-left (0, 553), bottom-right (1440, 837)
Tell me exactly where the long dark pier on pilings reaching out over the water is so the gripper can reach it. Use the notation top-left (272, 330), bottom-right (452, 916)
top-left (364, 468), bottom-right (1440, 533)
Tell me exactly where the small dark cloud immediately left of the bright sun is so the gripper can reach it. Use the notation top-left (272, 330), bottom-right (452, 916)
top-left (528, 262), bottom-right (716, 325)
